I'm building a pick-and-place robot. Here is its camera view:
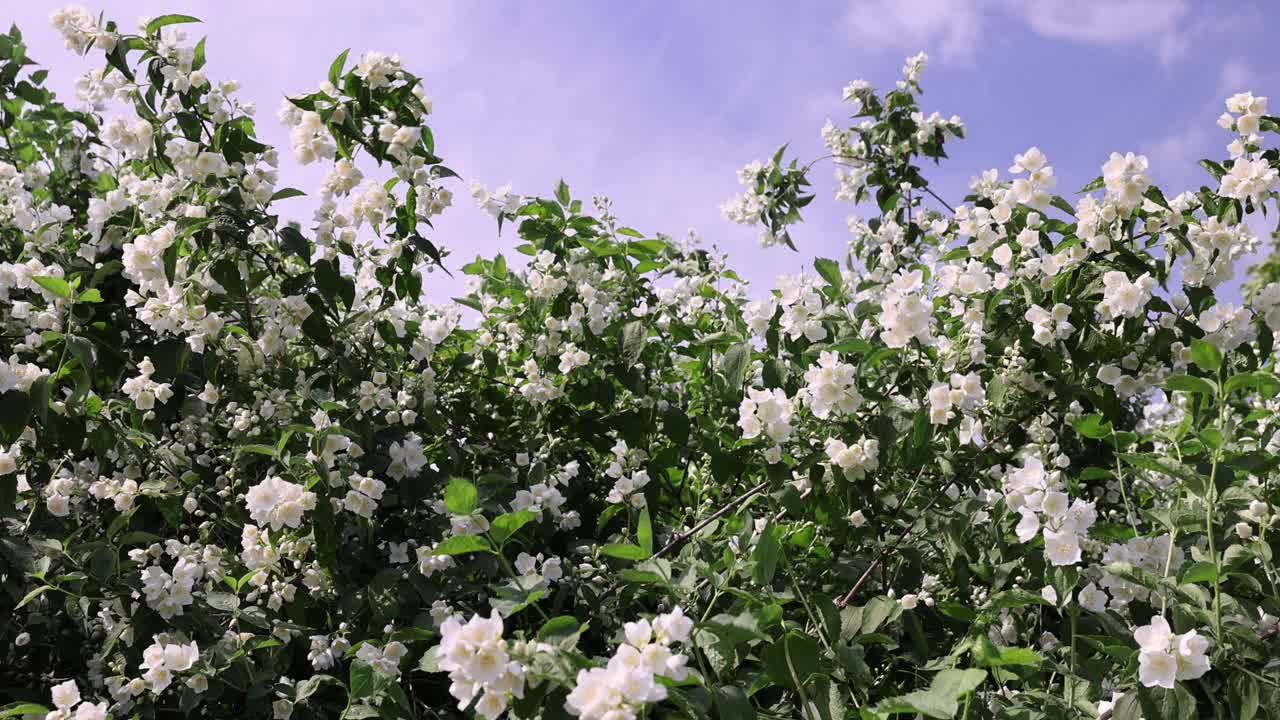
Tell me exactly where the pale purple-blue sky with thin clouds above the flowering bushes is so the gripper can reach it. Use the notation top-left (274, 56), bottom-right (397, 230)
top-left (10, 0), bottom-right (1280, 299)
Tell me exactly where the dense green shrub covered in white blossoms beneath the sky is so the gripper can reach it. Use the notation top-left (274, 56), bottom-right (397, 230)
top-left (0, 8), bottom-right (1280, 720)
